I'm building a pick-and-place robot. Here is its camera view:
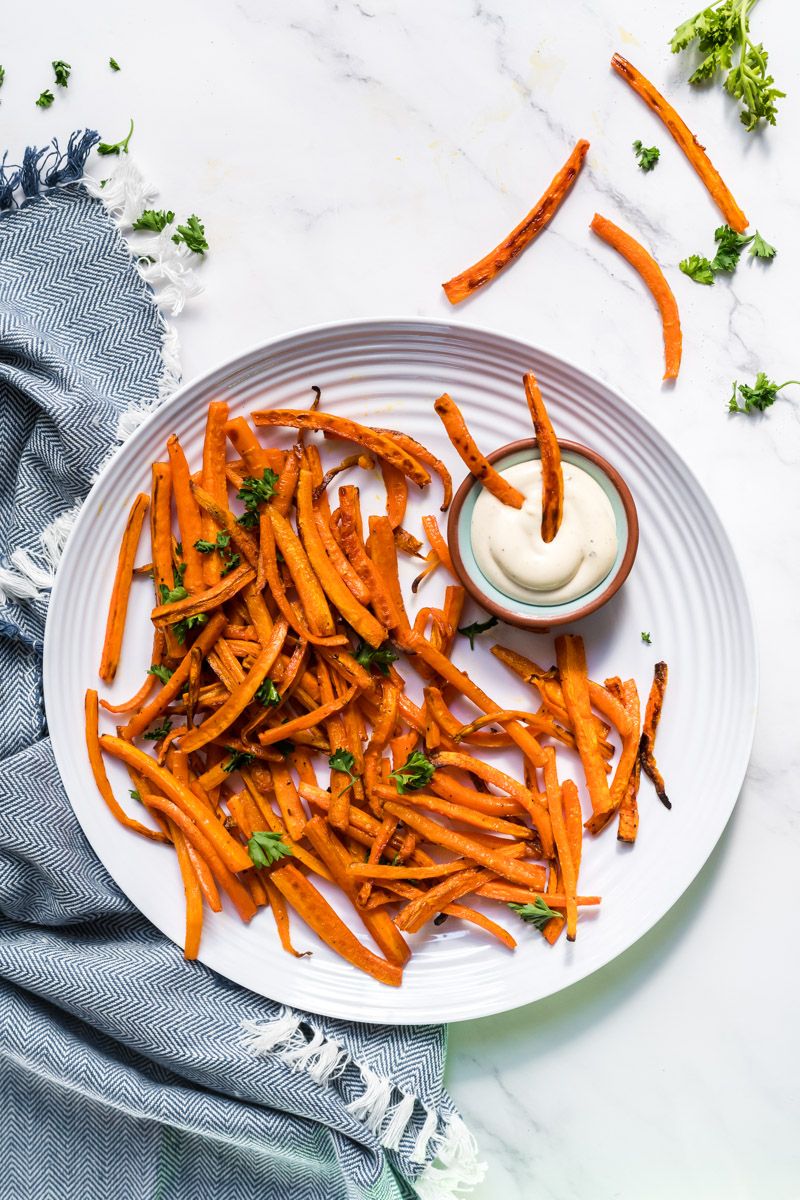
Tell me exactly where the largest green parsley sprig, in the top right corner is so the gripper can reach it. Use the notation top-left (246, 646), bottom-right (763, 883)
top-left (669, 0), bottom-right (786, 131)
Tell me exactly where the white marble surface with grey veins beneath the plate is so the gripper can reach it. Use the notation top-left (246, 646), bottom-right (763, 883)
top-left (0, 0), bottom-right (800, 1200)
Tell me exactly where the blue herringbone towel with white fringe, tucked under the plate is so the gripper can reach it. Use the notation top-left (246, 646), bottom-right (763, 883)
top-left (0, 133), bottom-right (480, 1200)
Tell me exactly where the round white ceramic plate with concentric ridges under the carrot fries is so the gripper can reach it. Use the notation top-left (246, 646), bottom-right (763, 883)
top-left (44, 320), bottom-right (757, 1024)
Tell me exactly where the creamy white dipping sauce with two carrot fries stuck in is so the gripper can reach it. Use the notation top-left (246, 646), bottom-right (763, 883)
top-left (470, 458), bottom-right (616, 605)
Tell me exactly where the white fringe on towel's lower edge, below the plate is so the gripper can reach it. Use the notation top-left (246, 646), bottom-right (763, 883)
top-left (242, 1009), bottom-right (486, 1200)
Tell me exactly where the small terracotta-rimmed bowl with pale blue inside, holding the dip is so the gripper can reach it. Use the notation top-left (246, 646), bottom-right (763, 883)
top-left (447, 439), bottom-right (639, 632)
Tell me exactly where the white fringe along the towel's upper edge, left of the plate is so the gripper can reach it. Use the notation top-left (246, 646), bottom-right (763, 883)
top-left (0, 155), bottom-right (203, 605)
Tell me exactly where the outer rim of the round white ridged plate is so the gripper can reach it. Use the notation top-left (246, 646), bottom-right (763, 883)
top-left (42, 314), bottom-right (760, 1025)
